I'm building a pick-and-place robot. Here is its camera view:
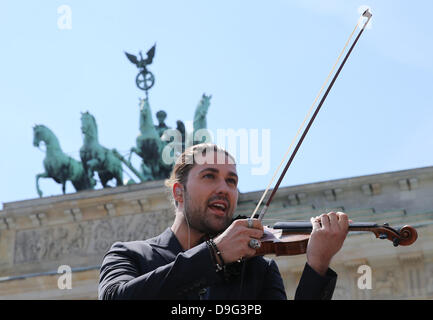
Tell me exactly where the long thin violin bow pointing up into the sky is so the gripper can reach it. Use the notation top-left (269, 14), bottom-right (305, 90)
top-left (251, 9), bottom-right (372, 221)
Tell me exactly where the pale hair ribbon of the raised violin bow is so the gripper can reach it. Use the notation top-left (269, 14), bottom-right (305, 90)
top-left (251, 16), bottom-right (363, 220)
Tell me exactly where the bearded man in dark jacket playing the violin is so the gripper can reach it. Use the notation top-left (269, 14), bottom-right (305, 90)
top-left (99, 144), bottom-right (349, 300)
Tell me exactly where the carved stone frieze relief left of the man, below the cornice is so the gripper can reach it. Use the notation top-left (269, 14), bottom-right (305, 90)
top-left (14, 211), bottom-right (174, 264)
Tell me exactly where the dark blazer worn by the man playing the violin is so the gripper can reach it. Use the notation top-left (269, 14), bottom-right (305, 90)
top-left (98, 228), bottom-right (337, 300)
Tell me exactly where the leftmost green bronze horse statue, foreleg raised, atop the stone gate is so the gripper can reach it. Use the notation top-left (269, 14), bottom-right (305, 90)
top-left (33, 125), bottom-right (95, 197)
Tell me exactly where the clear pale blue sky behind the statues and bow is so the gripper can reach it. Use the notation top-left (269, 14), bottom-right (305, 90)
top-left (0, 0), bottom-right (433, 208)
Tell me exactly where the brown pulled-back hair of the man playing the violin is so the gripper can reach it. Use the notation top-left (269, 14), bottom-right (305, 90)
top-left (165, 143), bottom-right (235, 207)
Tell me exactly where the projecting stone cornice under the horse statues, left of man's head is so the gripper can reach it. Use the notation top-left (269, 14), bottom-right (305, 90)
top-left (0, 181), bottom-right (171, 230)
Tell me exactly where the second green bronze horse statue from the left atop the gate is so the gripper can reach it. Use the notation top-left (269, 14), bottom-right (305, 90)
top-left (80, 112), bottom-right (123, 188)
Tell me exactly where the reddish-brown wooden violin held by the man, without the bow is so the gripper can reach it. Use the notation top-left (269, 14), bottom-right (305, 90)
top-left (256, 221), bottom-right (418, 256)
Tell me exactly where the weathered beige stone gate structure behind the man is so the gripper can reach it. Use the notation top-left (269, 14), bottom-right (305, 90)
top-left (0, 167), bottom-right (433, 299)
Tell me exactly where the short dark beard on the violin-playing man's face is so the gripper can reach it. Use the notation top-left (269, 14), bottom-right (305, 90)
top-left (184, 190), bottom-right (233, 236)
